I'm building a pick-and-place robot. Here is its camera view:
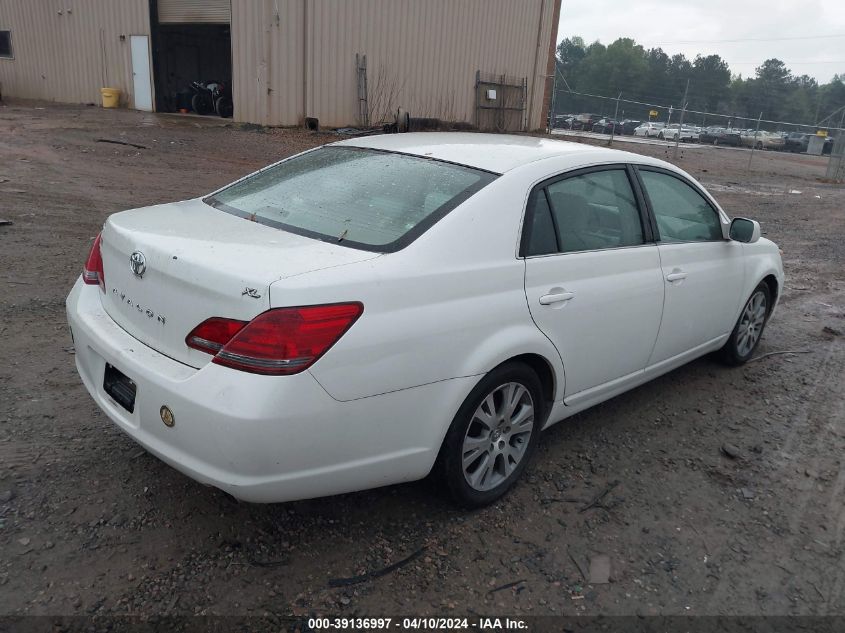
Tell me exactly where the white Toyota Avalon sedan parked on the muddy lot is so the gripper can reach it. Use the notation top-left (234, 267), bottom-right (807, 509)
top-left (67, 133), bottom-right (784, 506)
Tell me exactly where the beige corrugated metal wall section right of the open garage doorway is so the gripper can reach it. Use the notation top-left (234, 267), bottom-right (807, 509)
top-left (232, 0), bottom-right (560, 129)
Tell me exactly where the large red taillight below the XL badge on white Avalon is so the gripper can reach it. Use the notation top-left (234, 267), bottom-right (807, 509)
top-left (185, 303), bottom-right (364, 376)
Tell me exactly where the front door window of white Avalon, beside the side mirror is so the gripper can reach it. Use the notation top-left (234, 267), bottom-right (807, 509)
top-left (640, 170), bottom-right (723, 242)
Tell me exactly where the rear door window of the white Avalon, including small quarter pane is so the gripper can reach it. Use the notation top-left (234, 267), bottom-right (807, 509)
top-left (527, 169), bottom-right (644, 255)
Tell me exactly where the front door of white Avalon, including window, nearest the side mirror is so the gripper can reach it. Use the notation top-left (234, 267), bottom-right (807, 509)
top-left (637, 167), bottom-right (745, 365)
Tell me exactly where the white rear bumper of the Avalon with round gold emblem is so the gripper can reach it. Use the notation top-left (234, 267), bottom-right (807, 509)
top-left (66, 280), bottom-right (474, 502)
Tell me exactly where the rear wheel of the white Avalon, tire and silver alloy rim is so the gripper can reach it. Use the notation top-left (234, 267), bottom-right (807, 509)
top-left (435, 362), bottom-right (547, 508)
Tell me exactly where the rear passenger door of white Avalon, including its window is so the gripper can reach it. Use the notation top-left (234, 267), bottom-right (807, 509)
top-left (521, 165), bottom-right (663, 398)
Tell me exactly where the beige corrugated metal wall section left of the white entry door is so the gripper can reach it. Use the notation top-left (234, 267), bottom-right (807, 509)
top-left (0, 0), bottom-right (150, 107)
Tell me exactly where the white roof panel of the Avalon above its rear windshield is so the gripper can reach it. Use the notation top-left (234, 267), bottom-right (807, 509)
top-left (332, 132), bottom-right (646, 174)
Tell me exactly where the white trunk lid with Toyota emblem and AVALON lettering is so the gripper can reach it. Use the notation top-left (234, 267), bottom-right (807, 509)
top-left (102, 200), bottom-right (377, 368)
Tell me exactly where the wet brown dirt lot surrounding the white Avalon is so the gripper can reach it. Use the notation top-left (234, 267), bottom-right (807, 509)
top-left (0, 102), bottom-right (845, 616)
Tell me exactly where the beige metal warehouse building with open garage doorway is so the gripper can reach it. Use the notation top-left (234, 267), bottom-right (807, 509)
top-left (0, 0), bottom-right (560, 130)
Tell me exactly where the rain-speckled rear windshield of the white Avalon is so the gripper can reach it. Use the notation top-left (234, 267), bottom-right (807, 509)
top-left (205, 147), bottom-right (496, 252)
